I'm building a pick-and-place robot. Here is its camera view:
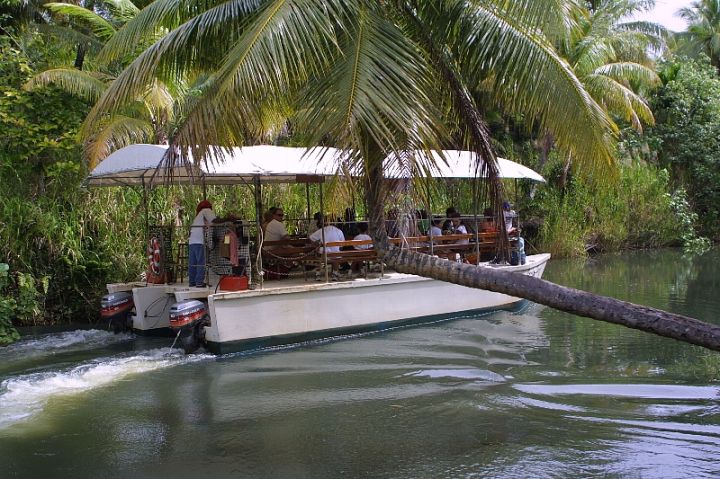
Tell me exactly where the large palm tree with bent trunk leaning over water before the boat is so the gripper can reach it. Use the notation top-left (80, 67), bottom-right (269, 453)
top-left (84, 0), bottom-right (720, 348)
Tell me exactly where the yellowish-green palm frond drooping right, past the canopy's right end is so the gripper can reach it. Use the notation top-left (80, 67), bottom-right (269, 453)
top-left (462, 1), bottom-right (617, 172)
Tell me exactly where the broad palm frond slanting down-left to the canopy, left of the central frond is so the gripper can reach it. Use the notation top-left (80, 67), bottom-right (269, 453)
top-left (169, 0), bottom-right (358, 161)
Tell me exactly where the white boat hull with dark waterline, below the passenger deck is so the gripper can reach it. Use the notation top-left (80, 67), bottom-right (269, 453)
top-left (108, 254), bottom-right (550, 353)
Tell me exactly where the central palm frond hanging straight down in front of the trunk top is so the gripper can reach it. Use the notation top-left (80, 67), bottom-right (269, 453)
top-left (296, 5), bottom-right (442, 158)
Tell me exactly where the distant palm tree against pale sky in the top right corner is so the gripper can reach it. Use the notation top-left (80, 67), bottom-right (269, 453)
top-left (677, 0), bottom-right (720, 71)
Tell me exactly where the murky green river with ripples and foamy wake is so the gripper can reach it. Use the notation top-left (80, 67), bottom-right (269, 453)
top-left (0, 250), bottom-right (720, 479)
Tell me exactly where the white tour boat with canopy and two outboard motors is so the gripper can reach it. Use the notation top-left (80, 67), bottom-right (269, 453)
top-left (88, 145), bottom-right (550, 354)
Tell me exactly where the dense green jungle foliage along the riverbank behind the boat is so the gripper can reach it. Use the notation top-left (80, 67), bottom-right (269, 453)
top-left (0, 2), bottom-right (720, 344)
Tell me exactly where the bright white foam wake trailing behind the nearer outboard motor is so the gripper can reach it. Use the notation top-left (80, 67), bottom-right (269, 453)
top-left (0, 348), bottom-right (214, 430)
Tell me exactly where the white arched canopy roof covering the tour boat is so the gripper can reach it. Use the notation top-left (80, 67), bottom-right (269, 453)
top-left (87, 144), bottom-right (545, 186)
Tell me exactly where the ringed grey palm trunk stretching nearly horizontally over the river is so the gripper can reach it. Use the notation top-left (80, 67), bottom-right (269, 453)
top-left (383, 248), bottom-right (720, 351)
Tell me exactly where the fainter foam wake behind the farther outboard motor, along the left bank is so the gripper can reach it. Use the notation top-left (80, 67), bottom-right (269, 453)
top-left (0, 329), bottom-right (133, 358)
